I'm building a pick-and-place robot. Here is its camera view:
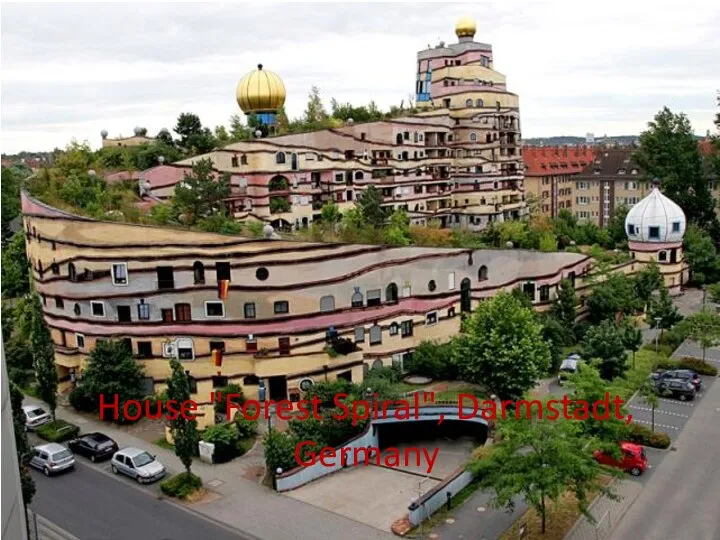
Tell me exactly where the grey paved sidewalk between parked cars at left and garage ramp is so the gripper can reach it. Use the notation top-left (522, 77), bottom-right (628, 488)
top-left (25, 398), bottom-right (394, 540)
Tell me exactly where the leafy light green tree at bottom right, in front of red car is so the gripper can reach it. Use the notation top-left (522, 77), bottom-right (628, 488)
top-left (469, 417), bottom-right (612, 534)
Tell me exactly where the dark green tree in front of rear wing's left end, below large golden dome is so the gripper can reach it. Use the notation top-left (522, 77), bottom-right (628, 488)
top-left (172, 159), bottom-right (230, 225)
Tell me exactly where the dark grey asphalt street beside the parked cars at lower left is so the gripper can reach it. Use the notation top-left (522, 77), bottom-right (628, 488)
top-left (32, 456), bottom-right (255, 540)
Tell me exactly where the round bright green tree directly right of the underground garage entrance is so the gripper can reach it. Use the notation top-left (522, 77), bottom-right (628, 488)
top-left (453, 293), bottom-right (550, 399)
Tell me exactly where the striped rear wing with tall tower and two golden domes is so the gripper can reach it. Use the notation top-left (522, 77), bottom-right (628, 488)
top-left (141, 16), bottom-right (527, 230)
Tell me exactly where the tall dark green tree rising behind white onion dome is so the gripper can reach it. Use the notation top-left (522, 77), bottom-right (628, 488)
top-left (634, 107), bottom-right (717, 230)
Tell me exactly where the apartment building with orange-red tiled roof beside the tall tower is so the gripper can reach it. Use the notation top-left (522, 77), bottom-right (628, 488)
top-left (523, 146), bottom-right (593, 218)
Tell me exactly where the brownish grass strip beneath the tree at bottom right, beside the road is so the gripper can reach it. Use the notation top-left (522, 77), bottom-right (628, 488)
top-left (500, 476), bottom-right (611, 540)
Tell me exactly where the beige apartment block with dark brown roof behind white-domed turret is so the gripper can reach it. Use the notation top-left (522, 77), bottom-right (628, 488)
top-left (573, 147), bottom-right (652, 227)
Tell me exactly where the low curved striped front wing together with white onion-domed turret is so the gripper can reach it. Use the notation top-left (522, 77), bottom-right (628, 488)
top-left (22, 179), bottom-right (687, 425)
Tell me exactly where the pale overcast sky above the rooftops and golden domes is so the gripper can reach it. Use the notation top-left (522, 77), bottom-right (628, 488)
top-left (0, 0), bottom-right (720, 153)
